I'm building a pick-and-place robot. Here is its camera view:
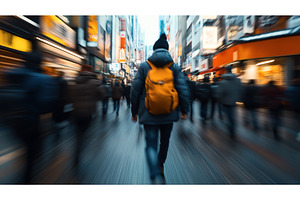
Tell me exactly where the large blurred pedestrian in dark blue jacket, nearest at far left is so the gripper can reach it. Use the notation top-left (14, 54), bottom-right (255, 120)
top-left (0, 52), bottom-right (57, 184)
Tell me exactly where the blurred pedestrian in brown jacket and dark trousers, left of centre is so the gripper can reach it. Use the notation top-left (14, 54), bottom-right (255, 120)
top-left (72, 64), bottom-right (100, 167)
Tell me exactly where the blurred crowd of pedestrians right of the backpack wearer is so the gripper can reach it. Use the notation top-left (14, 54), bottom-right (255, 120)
top-left (187, 66), bottom-right (300, 141)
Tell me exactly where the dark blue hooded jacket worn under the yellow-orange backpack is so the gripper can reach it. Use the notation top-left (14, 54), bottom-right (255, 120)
top-left (130, 49), bottom-right (190, 124)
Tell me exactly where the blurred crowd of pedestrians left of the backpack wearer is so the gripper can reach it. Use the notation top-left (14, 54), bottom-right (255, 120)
top-left (0, 52), bottom-right (130, 183)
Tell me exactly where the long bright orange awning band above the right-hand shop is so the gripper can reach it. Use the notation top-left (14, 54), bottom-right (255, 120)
top-left (213, 35), bottom-right (300, 67)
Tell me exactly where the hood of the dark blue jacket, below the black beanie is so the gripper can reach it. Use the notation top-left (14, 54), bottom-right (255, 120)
top-left (148, 48), bottom-right (173, 67)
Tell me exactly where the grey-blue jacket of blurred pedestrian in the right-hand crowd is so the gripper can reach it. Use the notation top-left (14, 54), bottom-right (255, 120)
top-left (218, 73), bottom-right (243, 106)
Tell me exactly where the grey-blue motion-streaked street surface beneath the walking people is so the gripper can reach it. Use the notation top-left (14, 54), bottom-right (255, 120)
top-left (0, 100), bottom-right (300, 185)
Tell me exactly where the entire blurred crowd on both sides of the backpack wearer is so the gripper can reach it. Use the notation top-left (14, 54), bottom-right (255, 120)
top-left (0, 53), bottom-right (300, 183)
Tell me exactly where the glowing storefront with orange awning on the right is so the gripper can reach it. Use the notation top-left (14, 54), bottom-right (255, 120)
top-left (213, 28), bottom-right (300, 86)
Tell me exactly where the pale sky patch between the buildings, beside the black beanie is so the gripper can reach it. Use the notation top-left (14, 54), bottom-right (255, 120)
top-left (138, 15), bottom-right (159, 45)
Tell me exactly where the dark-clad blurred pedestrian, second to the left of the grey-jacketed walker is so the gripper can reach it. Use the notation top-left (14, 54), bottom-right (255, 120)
top-left (195, 76), bottom-right (211, 123)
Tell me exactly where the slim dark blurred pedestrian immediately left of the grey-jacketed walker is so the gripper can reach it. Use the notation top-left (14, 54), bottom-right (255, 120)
top-left (210, 77), bottom-right (223, 119)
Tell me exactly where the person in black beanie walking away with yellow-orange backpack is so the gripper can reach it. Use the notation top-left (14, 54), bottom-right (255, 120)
top-left (130, 34), bottom-right (190, 184)
